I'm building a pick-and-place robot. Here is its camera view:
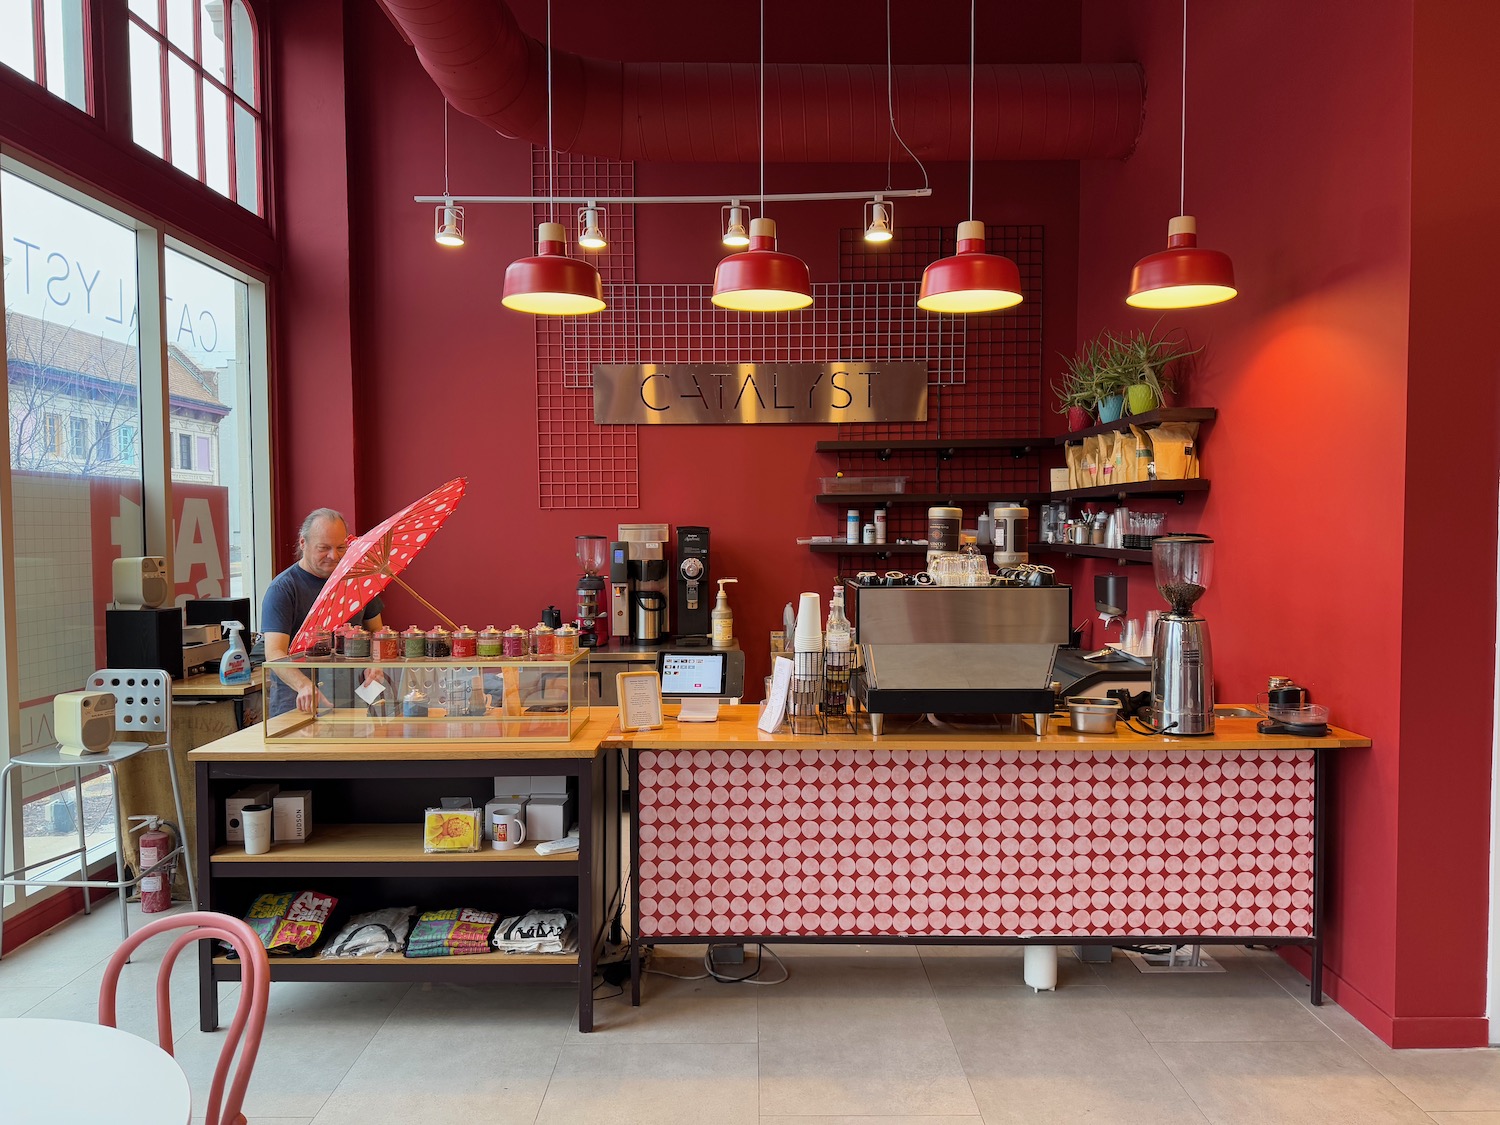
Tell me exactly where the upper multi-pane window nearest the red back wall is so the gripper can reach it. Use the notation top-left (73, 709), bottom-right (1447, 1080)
top-left (129, 0), bottom-right (261, 213)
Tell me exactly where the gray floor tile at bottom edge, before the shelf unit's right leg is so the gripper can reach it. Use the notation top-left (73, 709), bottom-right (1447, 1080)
top-left (537, 1037), bottom-right (761, 1125)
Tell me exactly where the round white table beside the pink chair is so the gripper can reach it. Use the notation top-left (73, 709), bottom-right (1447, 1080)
top-left (0, 1017), bottom-right (192, 1125)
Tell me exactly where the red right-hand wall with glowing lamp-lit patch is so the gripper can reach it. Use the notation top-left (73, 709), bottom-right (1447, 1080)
top-left (1079, 0), bottom-right (1497, 1046)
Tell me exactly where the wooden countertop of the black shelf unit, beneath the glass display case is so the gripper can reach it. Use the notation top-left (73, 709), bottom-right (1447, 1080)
top-left (188, 707), bottom-right (615, 762)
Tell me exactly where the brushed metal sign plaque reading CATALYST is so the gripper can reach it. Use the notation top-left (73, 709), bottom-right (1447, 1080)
top-left (594, 360), bottom-right (927, 426)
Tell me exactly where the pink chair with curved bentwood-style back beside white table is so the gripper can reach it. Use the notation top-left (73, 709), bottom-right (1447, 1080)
top-left (99, 911), bottom-right (272, 1125)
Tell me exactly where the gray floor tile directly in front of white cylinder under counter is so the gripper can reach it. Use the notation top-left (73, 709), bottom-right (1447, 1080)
top-left (938, 987), bottom-right (1205, 1125)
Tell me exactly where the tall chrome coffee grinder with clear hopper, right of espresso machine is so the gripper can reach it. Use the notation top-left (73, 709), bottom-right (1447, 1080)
top-left (1151, 536), bottom-right (1214, 735)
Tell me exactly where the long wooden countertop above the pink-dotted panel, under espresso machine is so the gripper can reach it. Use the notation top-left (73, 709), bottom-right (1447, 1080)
top-left (609, 705), bottom-right (1370, 752)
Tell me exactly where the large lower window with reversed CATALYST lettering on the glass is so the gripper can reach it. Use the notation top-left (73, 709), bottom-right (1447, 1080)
top-left (0, 165), bottom-right (270, 909)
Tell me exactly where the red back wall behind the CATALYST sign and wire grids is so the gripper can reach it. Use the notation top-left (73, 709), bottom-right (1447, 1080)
top-left (270, 5), bottom-right (1077, 698)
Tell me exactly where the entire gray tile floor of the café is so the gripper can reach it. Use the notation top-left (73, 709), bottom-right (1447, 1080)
top-left (0, 902), bottom-right (1500, 1125)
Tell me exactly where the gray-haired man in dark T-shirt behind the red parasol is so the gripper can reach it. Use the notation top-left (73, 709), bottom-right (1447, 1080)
top-left (261, 509), bottom-right (384, 716)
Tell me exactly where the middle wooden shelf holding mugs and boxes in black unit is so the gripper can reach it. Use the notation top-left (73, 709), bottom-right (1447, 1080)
top-left (210, 824), bottom-right (578, 875)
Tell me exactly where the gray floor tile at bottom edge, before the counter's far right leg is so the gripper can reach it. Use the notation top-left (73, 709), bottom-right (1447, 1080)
top-left (1155, 1043), bottom-right (1430, 1125)
